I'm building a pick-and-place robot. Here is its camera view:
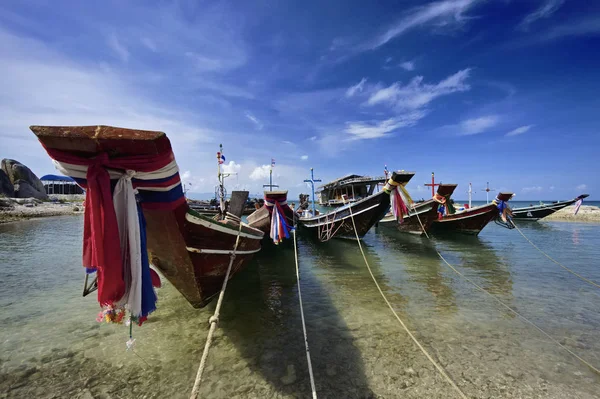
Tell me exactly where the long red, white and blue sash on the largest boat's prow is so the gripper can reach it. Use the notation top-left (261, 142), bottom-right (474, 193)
top-left (40, 148), bottom-right (178, 321)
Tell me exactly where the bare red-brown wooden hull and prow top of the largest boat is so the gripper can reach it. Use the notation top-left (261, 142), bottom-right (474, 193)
top-left (31, 126), bottom-right (264, 307)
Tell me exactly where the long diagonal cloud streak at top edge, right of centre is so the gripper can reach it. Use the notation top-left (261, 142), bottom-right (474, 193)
top-left (366, 0), bottom-right (478, 50)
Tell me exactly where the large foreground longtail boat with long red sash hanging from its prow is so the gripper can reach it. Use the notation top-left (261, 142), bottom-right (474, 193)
top-left (31, 126), bottom-right (264, 317)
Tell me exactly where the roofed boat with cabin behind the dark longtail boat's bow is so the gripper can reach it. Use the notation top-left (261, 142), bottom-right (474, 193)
top-left (317, 175), bottom-right (387, 206)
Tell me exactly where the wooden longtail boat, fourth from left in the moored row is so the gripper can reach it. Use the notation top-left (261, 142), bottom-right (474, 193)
top-left (379, 184), bottom-right (457, 235)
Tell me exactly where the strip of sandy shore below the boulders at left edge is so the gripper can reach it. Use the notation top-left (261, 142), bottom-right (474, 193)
top-left (0, 196), bottom-right (84, 224)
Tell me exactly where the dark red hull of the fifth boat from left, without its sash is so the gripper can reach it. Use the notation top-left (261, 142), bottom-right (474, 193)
top-left (431, 204), bottom-right (498, 235)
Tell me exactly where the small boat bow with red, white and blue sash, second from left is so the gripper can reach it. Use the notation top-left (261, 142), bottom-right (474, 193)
top-left (248, 191), bottom-right (295, 244)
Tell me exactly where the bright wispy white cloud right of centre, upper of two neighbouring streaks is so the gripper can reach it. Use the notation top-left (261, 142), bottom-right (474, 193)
top-left (367, 68), bottom-right (471, 110)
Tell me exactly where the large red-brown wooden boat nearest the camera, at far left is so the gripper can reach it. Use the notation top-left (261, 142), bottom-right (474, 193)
top-left (31, 126), bottom-right (264, 307)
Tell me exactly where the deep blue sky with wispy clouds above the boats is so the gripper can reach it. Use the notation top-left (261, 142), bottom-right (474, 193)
top-left (0, 0), bottom-right (600, 200)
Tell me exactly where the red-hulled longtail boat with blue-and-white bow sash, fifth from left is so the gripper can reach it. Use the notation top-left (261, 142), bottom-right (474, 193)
top-left (431, 192), bottom-right (513, 235)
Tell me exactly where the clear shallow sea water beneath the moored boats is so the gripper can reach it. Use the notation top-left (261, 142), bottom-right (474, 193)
top-left (0, 217), bottom-right (600, 399)
